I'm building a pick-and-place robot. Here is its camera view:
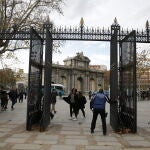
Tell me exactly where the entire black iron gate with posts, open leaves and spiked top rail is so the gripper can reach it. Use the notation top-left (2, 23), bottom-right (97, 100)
top-left (0, 18), bottom-right (146, 132)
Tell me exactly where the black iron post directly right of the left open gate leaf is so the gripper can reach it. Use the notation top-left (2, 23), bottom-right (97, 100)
top-left (40, 26), bottom-right (53, 131)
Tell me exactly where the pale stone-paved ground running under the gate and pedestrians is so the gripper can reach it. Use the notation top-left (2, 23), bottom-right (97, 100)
top-left (0, 96), bottom-right (150, 150)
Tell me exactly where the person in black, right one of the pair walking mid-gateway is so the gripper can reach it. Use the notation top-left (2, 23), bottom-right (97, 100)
top-left (77, 91), bottom-right (87, 118)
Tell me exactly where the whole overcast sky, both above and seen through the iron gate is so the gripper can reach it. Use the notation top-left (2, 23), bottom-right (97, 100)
top-left (14, 0), bottom-right (150, 72)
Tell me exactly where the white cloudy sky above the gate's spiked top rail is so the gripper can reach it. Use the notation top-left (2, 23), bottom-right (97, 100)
top-left (52, 0), bottom-right (150, 28)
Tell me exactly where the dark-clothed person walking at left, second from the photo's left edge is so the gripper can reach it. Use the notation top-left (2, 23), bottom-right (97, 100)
top-left (9, 87), bottom-right (18, 110)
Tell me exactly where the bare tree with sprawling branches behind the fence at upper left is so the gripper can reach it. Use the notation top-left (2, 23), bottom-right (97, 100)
top-left (0, 0), bottom-right (64, 54)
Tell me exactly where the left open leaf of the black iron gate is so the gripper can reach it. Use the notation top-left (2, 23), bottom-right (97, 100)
top-left (26, 28), bottom-right (43, 130)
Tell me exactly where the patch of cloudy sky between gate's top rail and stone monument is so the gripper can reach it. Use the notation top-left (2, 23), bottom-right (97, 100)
top-left (53, 41), bottom-right (110, 69)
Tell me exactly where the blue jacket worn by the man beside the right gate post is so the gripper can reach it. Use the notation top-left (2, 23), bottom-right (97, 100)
top-left (90, 93), bottom-right (108, 109)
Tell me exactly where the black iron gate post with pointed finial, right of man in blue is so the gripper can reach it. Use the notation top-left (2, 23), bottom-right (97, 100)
top-left (110, 21), bottom-right (120, 131)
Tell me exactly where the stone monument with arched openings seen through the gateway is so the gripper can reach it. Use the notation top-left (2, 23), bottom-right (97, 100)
top-left (52, 52), bottom-right (104, 94)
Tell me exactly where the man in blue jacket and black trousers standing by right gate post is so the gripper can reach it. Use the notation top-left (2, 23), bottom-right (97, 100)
top-left (90, 89), bottom-right (109, 135)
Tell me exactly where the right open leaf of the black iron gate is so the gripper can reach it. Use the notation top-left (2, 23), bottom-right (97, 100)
top-left (119, 31), bottom-right (137, 133)
